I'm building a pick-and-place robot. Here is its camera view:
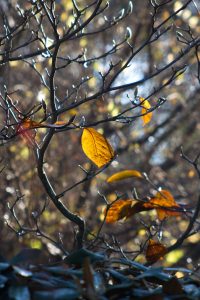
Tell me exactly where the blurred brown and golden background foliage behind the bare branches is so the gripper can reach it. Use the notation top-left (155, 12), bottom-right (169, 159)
top-left (0, 0), bottom-right (200, 267)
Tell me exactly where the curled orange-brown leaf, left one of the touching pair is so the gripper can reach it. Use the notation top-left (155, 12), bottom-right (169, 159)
top-left (106, 199), bottom-right (148, 223)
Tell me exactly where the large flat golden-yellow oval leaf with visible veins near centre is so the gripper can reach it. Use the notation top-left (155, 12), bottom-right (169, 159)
top-left (81, 128), bottom-right (114, 168)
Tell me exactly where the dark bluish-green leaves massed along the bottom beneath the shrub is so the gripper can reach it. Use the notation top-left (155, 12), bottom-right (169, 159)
top-left (0, 249), bottom-right (200, 300)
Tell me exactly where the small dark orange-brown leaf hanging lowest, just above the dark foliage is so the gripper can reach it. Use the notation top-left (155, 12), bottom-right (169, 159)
top-left (145, 239), bottom-right (167, 263)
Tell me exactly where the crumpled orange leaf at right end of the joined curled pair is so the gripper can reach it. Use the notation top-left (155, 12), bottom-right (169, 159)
top-left (144, 190), bottom-right (181, 221)
